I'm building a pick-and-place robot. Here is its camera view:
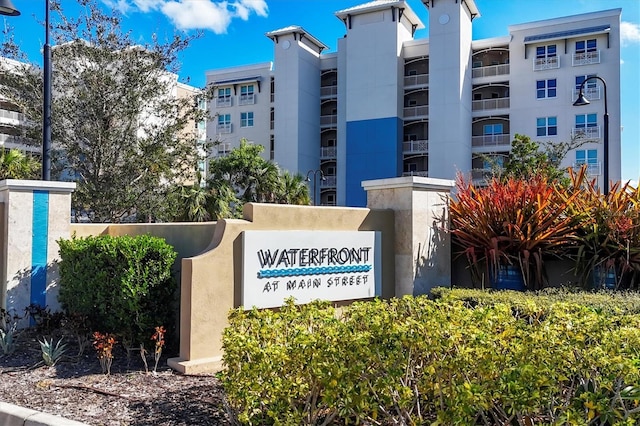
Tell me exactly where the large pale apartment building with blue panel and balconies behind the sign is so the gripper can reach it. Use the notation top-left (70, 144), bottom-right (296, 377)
top-left (206, 0), bottom-right (621, 206)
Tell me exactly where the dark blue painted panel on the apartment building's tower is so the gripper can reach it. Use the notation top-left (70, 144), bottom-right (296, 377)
top-left (346, 117), bottom-right (402, 207)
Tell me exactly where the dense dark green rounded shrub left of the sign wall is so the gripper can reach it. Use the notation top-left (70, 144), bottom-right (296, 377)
top-left (58, 235), bottom-right (176, 347)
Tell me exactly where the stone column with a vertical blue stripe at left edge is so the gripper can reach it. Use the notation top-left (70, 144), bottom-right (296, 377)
top-left (0, 179), bottom-right (76, 322)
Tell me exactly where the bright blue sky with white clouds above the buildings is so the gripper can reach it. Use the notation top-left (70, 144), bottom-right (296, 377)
top-left (0, 0), bottom-right (640, 182)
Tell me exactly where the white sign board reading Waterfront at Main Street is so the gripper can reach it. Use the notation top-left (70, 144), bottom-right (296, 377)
top-left (241, 231), bottom-right (382, 308)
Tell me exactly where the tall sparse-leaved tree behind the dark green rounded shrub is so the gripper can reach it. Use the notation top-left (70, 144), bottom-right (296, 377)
top-left (0, 0), bottom-right (207, 222)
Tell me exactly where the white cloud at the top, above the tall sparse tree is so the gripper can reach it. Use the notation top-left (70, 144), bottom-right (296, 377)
top-left (102, 0), bottom-right (269, 34)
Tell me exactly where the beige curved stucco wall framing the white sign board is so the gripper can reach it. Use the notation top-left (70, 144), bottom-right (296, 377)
top-left (169, 203), bottom-right (395, 373)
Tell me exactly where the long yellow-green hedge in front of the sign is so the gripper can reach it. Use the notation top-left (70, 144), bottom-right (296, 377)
top-left (222, 293), bottom-right (640, 425)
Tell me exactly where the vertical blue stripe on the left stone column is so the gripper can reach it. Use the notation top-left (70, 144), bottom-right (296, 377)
top-left (31, 191), bottom-right (49, 307)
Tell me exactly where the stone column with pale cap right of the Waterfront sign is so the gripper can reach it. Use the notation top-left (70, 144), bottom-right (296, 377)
top-left (362, 176), bottom-right (455, 297)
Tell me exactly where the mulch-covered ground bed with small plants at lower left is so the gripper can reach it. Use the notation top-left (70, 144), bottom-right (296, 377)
top-left (0, 330), bottom-right (232, 426)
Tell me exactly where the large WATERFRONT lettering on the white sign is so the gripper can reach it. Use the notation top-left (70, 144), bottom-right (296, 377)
top-left (257, 247), bottom-right (371, 268)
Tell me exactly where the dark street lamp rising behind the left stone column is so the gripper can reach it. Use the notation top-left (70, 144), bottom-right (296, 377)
top-left (0, 0), bottom-right (51, 180)
